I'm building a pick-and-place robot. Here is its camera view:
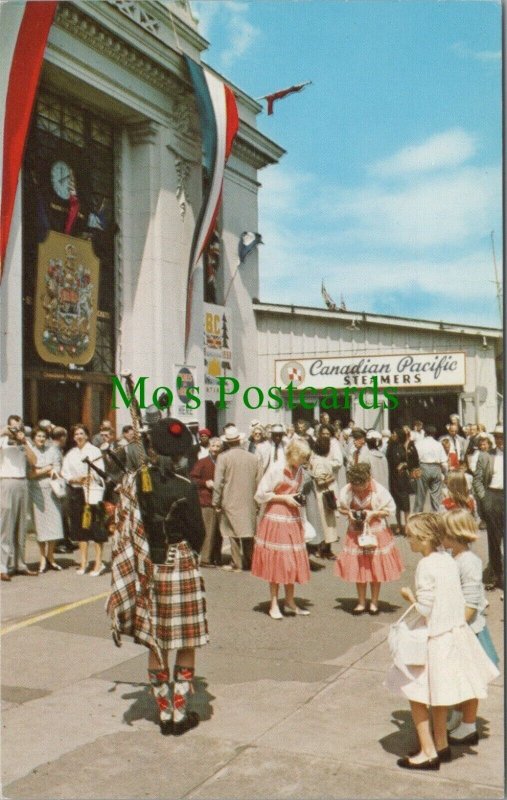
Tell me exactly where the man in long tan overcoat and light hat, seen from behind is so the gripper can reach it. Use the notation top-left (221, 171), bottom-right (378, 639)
top-left (212, 425), bottom-right (263, 572)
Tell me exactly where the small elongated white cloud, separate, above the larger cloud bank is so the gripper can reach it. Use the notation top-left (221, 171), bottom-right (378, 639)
top-left (369, 128), bottom-right (476, 177)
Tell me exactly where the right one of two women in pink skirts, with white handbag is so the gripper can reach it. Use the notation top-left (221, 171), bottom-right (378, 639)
top-left (335, 463), bottom-right (403, 614)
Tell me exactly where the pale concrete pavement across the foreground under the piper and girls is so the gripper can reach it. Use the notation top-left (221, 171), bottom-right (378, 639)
top-left (2, 542), bottom-right (504, 800)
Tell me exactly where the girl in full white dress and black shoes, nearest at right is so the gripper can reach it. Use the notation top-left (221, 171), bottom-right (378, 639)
top-left (387, 513), bottom-right (499, 769)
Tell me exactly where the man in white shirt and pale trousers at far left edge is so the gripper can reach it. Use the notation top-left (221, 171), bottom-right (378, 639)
top-left (0, 414), bottom-right (38, 581)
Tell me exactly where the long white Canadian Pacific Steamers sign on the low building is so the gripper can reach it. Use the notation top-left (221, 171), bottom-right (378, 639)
top-left (275, 352), bottom-right (465, 389)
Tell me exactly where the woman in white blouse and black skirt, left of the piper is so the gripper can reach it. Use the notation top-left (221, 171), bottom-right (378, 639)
top-left (62, 423), bottom-right (107, 577)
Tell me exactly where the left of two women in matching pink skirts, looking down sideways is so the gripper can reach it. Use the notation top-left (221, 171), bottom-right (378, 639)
top-left (252, 439), bottom-right (310, 619)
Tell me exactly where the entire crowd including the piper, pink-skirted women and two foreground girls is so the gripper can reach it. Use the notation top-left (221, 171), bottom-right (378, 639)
top-left (0, 410), bottom-right (504, 769)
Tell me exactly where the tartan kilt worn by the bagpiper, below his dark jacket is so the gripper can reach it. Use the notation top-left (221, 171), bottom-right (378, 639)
top-left (151, 542), bottom-right (209, 650)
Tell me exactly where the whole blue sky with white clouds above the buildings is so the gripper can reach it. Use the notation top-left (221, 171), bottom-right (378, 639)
top-left (192, 0), bottom-right (502, 326)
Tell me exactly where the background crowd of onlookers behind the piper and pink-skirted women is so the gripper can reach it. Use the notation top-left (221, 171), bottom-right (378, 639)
top-left (0, 410), bottom-right (503, 592)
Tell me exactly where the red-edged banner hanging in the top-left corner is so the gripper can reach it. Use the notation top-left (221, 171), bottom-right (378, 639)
top-left (0, 0), bottom-right (57, 280)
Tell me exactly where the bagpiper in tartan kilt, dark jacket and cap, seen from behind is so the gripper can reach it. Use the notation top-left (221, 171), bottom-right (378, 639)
top-left (107, 417), bottom-right (208, 736)
